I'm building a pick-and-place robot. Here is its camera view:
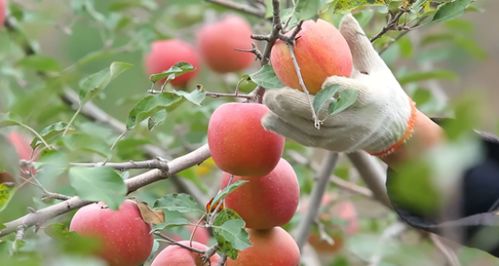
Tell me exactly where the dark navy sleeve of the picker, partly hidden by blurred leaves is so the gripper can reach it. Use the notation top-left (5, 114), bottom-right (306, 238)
top-left (386, 134), bottom-right (499, 257)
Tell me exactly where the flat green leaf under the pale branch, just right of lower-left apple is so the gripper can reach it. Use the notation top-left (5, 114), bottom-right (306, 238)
top-left (154, 193), bottom-right (204, 215)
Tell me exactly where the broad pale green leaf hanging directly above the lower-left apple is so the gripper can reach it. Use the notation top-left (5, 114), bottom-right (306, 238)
top-left (69, 167), bottom-right (127, 209)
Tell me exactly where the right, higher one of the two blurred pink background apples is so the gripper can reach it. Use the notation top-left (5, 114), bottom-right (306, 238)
top-left (197, 15), bottom-right (255, 73)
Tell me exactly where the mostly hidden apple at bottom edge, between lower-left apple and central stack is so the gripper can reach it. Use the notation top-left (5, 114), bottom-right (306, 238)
top-left (151, 240), bottom-right (220, 266)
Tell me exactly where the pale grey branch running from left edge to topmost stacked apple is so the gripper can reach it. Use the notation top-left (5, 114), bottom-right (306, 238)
top-left (0, 144), bottom-right (210, 237)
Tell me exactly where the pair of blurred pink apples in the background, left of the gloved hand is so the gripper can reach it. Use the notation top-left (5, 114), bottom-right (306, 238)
top-left (145, 15), bottom-right (255, 88)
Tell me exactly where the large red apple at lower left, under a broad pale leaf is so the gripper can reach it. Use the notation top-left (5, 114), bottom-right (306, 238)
top-left (69, 200), bottom-right (153, 266)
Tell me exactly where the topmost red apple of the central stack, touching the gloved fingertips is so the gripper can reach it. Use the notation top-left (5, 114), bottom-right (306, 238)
top-left (208, 103), bottom-right (284, 176)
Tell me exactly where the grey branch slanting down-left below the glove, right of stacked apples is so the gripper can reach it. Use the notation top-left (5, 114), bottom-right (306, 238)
top-left (295, 152), bottom-right (338, 250)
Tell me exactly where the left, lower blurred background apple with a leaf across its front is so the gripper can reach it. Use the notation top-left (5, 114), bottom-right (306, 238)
top-left (145, 39), bottom-right (199, 88)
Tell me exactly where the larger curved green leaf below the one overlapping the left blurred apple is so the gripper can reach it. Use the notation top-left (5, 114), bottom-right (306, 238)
top-left (126, 93), bottom-right (184, 129)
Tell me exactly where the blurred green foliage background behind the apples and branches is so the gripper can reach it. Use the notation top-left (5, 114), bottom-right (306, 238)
top-left (0, 0), bottom-right (499, 266)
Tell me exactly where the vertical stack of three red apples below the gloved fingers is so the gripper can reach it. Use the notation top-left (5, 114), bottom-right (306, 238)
top-left (208, 103), bottom-right (300, 266)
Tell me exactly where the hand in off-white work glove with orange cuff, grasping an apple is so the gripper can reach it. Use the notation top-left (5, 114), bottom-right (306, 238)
top-left (262, 15), bottom-right (417, 156)
